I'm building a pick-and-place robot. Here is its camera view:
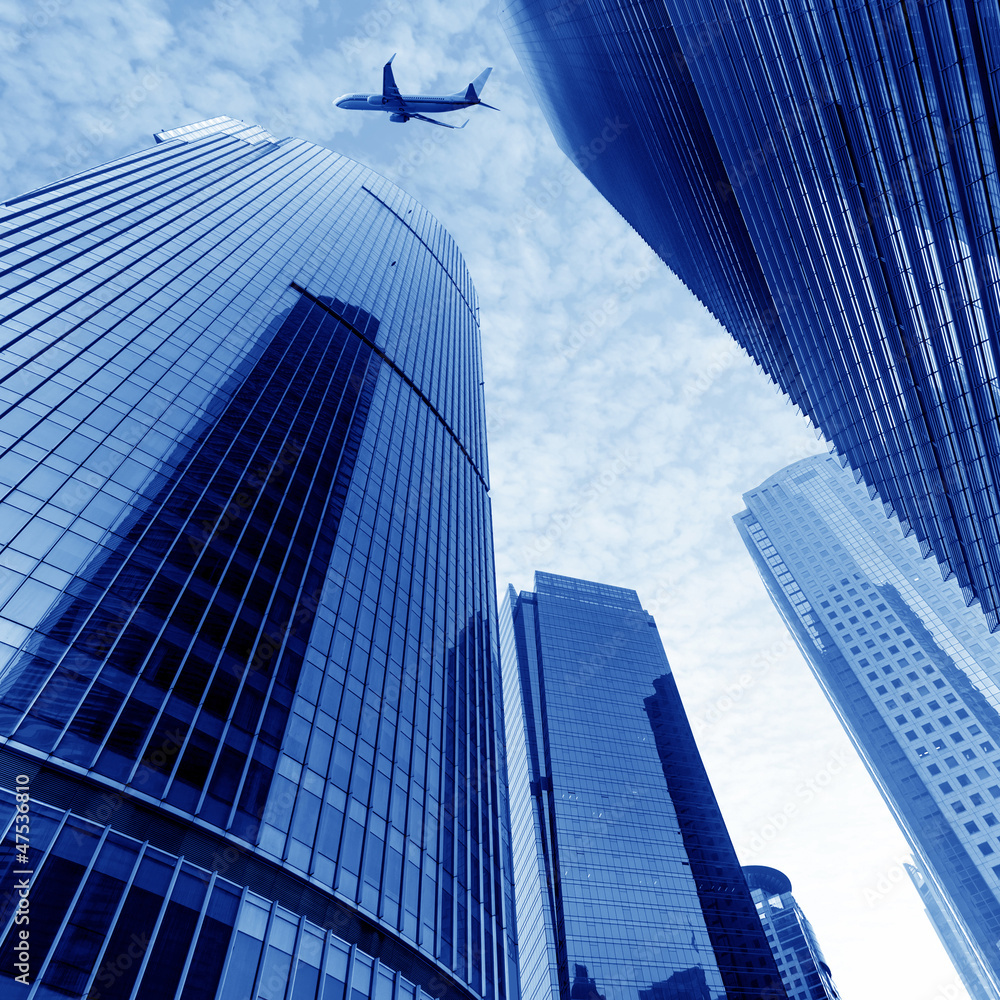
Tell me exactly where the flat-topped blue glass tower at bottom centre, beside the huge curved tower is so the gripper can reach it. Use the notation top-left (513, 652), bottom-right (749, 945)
top-left (500, 573), bottom-right (785, 1000)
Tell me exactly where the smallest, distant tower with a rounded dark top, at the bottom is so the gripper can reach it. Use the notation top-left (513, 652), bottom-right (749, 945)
top-left (743, 865), bottom-right (840, 1000)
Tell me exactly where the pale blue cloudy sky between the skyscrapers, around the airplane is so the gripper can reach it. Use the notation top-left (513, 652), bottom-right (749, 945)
top-left (0, 0), bottom-right (966, 1000)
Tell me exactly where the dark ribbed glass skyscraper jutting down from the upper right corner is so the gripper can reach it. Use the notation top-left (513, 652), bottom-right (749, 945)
top-left (500, 0), bottom-right (1000, 631)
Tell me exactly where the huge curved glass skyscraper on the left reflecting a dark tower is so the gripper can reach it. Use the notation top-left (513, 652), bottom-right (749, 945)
top-left (0, 118), bottom-right (517, 1000)
